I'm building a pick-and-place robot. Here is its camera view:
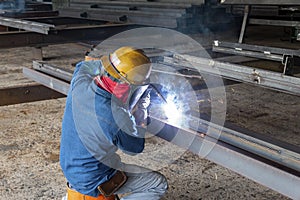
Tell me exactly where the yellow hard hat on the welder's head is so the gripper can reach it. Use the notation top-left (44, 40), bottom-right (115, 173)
top-left (101, 47), bottom-right (151, 85)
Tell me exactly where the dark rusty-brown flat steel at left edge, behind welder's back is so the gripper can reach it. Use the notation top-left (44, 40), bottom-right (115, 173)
top-left (0, 84), bottom-right (65, 106)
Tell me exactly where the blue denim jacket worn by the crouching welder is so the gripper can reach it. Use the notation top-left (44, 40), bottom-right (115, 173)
top-left (60, 61), bottom-right (145, 197)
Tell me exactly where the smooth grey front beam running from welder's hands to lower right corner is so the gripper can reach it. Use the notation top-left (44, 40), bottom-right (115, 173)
top-left (149, 117), bottom-right (300, 199)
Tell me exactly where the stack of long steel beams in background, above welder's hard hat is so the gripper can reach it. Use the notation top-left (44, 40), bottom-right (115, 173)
top-left (59, 0), bottom-right (233, 31)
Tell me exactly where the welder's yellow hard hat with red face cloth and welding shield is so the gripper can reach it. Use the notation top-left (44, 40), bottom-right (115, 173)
top-left (101, 47), bottom-right (151, 110)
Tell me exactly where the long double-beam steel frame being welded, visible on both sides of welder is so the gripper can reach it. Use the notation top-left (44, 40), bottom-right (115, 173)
top-left (23, 62), bottom-right (300, 199)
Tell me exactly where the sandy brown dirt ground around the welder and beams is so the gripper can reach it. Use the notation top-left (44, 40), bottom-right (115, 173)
top-left (0, 27), bottom-right (300, 200)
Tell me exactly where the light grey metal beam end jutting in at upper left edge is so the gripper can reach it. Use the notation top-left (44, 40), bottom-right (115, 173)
top-left (0, 17), bottom-right (54, 34)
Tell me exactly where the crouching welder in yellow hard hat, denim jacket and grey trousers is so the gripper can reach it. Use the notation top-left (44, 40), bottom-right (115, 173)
top-left (60, 47), bottom-right (168, 200)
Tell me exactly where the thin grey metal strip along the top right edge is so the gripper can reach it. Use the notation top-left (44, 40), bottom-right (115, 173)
top-left (221, 0), bottom-right (300, 5)
